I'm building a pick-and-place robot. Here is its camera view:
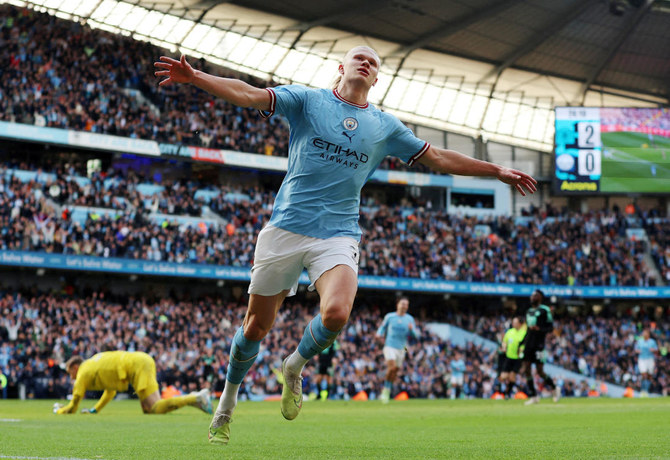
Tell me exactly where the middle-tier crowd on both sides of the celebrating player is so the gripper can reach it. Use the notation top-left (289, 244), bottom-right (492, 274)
top-left (0, 160), bottom-right (669, 286)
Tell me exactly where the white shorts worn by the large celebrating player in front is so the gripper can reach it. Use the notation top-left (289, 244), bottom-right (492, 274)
top-left (248, 225), bottom-right (359, 296)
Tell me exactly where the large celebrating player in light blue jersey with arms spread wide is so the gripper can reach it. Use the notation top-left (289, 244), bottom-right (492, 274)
top-left (154, 46), bottom-right (536, 444)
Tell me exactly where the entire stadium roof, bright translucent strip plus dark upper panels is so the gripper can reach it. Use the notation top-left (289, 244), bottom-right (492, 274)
top-left (13, 0), bottom-right (670, 151)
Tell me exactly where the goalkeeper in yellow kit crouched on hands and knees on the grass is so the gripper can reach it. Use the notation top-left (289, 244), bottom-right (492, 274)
top-left (54, 351), bottom-right (212, 414)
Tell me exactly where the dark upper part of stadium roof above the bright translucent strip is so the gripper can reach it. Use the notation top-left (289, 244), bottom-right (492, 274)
top-left (127, 0), bottom-right (670, 102)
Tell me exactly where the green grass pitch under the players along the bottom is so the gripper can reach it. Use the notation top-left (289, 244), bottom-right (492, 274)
top-left (0, 398), bottom-right (670, 460)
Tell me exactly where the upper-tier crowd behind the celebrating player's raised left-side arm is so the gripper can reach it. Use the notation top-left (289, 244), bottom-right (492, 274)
top-left (0, 5), bottom-right (436, 171)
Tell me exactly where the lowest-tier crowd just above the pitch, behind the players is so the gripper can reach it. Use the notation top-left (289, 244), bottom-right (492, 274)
top-left (0, 289), bottom-right (670, 399)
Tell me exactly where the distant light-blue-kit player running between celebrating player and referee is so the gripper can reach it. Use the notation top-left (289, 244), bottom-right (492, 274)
top-left (377, 297), bottom-right (419, 404)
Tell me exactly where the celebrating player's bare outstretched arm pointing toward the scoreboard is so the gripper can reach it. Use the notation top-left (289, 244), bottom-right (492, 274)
top-left (418, 146), bottom-right (537, 196)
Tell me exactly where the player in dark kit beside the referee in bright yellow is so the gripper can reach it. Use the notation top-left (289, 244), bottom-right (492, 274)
top-left (520, 289), bottom-right (561, 404)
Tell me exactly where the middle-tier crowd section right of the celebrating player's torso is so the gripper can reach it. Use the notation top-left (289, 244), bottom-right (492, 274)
top-left (360, 203), bottom-right (655, 286)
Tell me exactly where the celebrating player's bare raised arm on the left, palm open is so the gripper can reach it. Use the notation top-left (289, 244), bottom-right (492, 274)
top-left (154, 54), bottom-right (271, 110)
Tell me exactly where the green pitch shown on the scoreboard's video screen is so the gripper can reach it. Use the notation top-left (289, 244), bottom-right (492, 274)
top-left (600, 132), bottom-right (670, 193)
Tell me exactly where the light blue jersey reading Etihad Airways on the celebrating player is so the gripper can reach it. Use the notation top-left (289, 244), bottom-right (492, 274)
top-left (261, 85), bottom-right (430, 240)
